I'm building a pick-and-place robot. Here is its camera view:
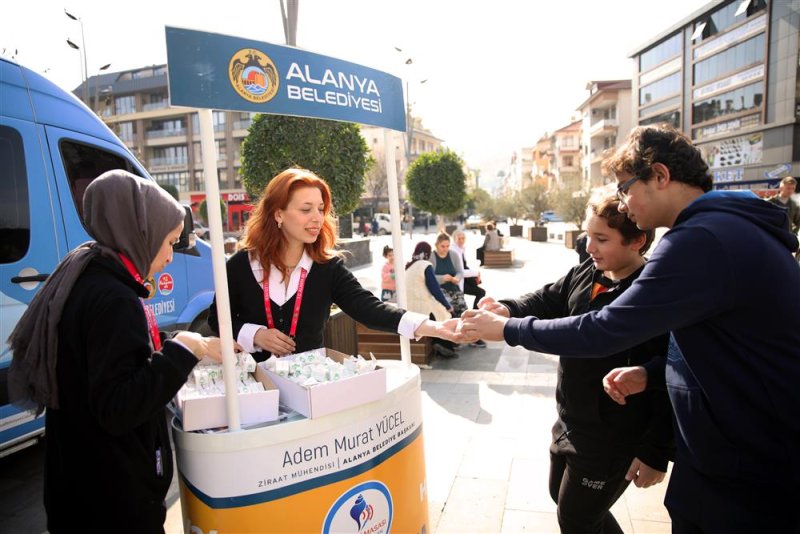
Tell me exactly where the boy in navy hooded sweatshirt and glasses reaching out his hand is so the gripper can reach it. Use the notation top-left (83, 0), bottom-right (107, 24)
top-left (461, 126), bottom-right (800, 534)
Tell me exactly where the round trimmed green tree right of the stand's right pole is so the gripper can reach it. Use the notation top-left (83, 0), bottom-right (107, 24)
top-left (406, 150), bottom-right (467, 219)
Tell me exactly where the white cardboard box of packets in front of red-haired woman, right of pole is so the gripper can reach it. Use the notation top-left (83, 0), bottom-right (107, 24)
top-left (258, 348), bottom-right (386, 419)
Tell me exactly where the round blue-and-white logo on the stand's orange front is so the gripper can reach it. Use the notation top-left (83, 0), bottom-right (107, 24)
top-left (322, 480), bottom-right (394, 534)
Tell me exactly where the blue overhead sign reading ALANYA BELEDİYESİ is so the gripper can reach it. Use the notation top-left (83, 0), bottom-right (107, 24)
top-left (166, 26), bottom-right (406, 131)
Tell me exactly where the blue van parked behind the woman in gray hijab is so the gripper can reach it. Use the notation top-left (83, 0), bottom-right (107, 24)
top-left (0, 58), bottom-right (214, 457)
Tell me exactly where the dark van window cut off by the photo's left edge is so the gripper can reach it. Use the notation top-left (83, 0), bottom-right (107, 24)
top-left (0, 126), bottom-right (31, 263)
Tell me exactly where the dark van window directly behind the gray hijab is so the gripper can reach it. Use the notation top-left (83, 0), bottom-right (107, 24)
top-left (60, 140), bottom-right (141, 221)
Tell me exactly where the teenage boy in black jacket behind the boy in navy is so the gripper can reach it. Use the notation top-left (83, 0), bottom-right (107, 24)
top-left (480, 198), bottom-right (673, 534)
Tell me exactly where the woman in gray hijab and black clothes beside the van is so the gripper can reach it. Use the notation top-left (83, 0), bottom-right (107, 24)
top-left (8, 170), bottom-right (220, 534)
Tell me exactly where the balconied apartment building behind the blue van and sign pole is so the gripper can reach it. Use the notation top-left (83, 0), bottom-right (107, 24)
top-left (81, 65), bottom-right (255, 231)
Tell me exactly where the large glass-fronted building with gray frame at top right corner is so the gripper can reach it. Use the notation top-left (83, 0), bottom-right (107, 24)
top-left (632, 0), bottom-right (800, 192)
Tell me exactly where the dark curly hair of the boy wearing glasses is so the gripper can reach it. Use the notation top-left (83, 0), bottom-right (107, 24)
top-left (603, 124), bottom-right (712, 192)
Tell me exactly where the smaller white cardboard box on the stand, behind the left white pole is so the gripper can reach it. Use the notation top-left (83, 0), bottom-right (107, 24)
top-left (175, 367), bottom-right (278, 432)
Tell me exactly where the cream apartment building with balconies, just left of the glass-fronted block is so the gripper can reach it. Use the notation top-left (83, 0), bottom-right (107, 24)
top-left (578, 80), bottom-right (633, 189)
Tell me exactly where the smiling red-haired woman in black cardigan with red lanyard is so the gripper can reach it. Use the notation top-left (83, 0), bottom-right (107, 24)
top-left (208, 168), bottom-right (452, 361)
